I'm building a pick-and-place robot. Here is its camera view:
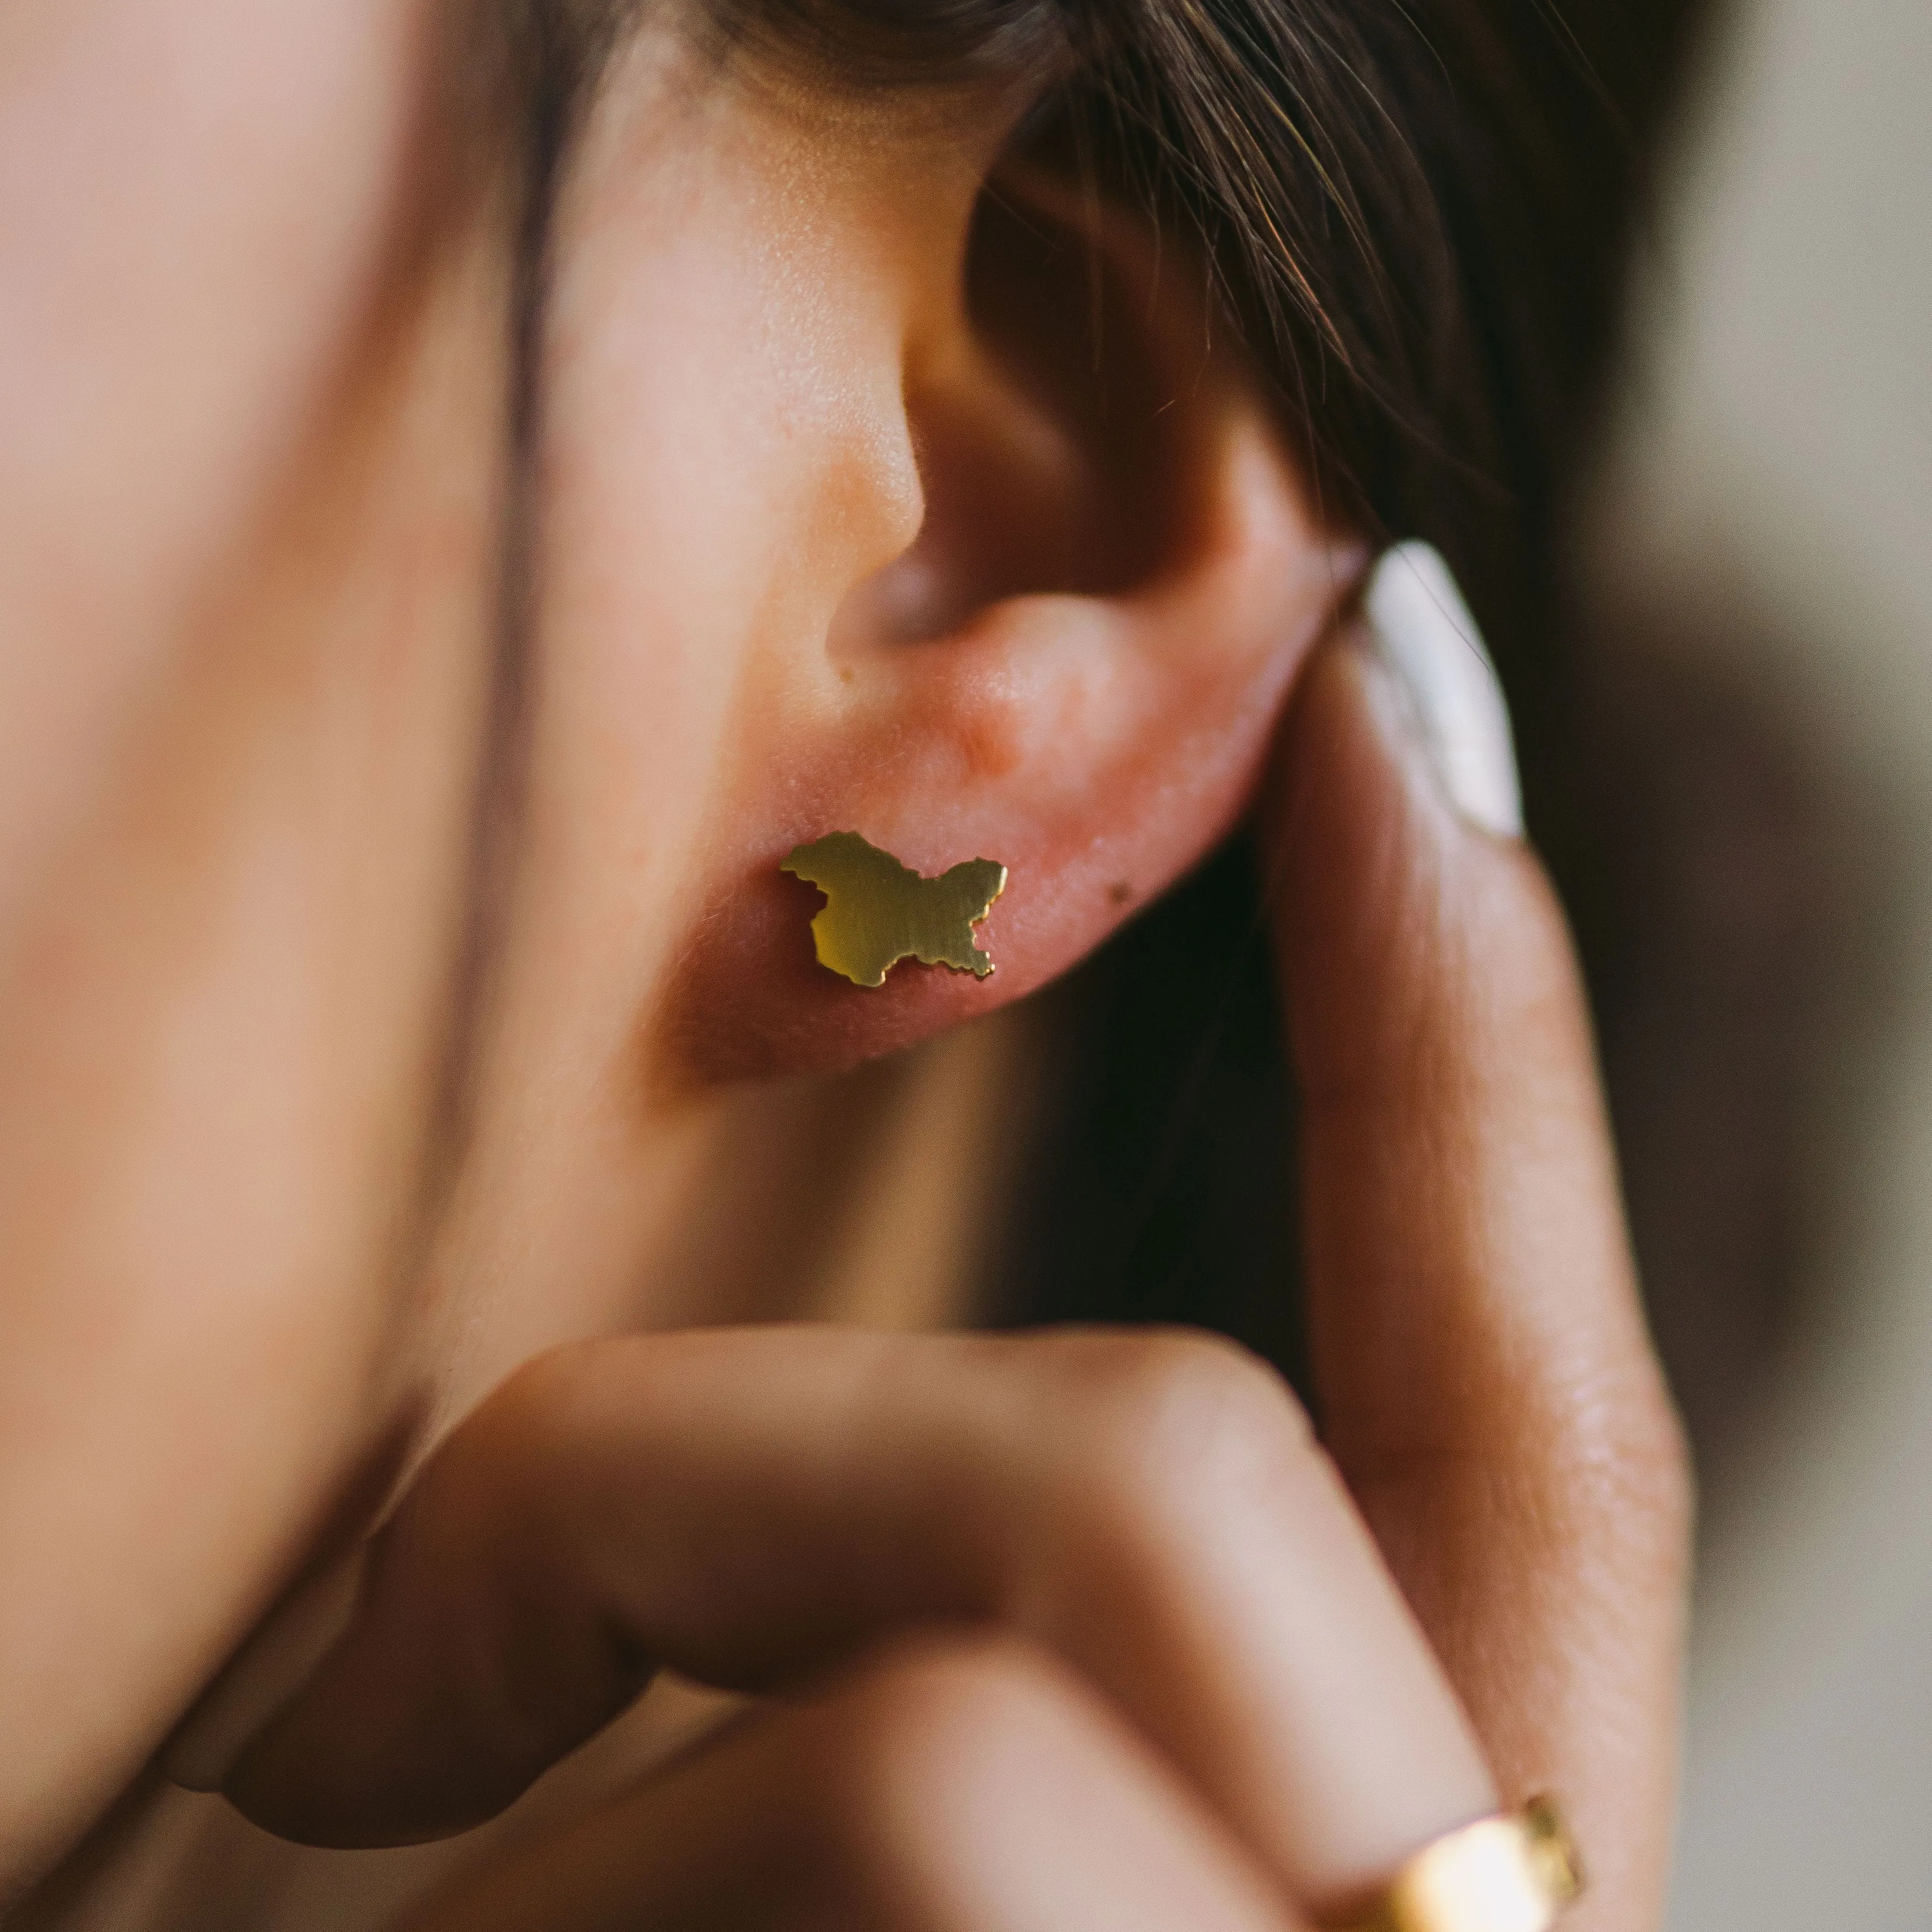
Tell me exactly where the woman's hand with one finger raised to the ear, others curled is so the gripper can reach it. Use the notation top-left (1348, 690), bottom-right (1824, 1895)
top-left (188, 595), bottom-right (1685, 1932)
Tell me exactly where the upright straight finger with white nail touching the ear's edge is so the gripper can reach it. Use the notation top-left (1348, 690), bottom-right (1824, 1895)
top-left (1271, 551), bottom-right (1685, 1924)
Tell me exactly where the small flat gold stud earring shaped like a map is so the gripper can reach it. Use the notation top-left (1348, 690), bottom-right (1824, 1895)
top-left (779, 833), bottom-right (1007, 985)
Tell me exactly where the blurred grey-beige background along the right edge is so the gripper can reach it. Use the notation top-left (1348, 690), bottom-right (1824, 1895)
top-left (1578, 0), bottom-right (1932, 1932)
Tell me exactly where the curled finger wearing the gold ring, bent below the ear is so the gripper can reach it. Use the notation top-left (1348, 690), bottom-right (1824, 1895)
top-left (200, 1329), bottom-right (1490, 1903)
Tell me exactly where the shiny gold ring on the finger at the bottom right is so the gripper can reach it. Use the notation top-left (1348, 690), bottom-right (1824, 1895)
top-left (1335, 1799), bottom-right (1582, 1932)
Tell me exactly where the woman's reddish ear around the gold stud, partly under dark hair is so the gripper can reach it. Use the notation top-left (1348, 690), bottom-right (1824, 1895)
top-left (667, 166), bottom-right (1360, 1080)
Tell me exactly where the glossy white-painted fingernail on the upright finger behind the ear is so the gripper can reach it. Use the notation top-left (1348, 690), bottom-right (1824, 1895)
top-left (1364, 543), bottom-right (1523, 838)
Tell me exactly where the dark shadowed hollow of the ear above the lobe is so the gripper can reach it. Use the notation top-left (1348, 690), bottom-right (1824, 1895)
top-left (831, 184), bottom-right (1179, 653)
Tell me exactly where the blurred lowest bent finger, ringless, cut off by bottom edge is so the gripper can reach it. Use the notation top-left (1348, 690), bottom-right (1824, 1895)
top-left (404, 1642), bottom-right (1302, 1932)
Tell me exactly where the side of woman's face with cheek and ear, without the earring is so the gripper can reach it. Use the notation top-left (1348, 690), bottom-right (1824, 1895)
top-left (0, 0), bottom-right (1352, 1882)
